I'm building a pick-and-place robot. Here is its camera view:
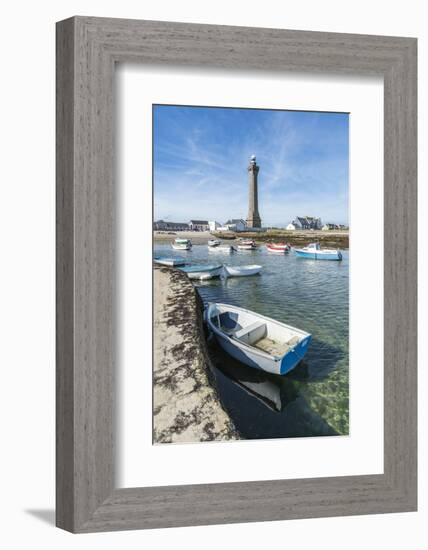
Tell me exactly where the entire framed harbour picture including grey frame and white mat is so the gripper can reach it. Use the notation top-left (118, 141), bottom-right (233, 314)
top-left (57, 17), bottom-right (417, 532)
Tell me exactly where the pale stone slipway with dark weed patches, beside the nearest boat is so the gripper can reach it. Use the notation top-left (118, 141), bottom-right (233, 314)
top-left (153, 266), bottom-right (239, 443)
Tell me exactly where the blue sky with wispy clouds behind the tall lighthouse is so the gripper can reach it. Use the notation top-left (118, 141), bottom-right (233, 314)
top-left (153, 105), bottom-right (349, 227)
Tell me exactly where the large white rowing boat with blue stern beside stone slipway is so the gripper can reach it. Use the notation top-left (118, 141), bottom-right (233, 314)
top-left (205, 303), bottom-right (312, 375)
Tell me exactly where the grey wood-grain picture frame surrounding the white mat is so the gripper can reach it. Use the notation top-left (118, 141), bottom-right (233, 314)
top-left (56, 17), bottom-right (417, 532)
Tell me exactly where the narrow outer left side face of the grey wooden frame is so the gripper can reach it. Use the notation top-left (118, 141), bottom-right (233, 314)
top-left (56, 18), bottom-right (75, 530)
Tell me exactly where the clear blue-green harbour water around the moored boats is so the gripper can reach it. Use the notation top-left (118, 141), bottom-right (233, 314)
top-left (155, 244), bottom-right (349, 439)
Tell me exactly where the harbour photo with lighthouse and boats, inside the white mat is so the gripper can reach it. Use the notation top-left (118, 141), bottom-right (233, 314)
top-left (153, 105), bottom-right (349, 443)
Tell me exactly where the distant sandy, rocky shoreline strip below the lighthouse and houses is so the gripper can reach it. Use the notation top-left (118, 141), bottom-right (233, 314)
top-left (153, 229), bottom-right (349, 249)
